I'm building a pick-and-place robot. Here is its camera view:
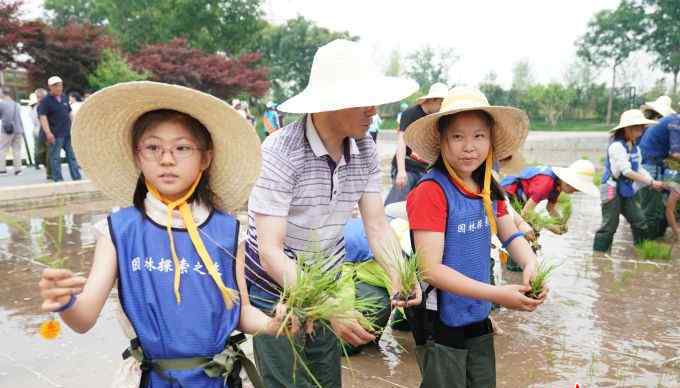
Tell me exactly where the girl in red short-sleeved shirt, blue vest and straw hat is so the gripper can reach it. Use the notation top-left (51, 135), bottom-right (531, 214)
top-left (406, 87), bottom-right (548, 388)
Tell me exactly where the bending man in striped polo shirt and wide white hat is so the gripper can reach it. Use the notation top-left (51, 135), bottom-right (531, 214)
top-left (246, 40), bottom-right (420, 388)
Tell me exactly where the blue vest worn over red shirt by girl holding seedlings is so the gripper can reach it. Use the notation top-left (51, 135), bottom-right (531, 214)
top-left (420, 169), bottom-right (496, 327)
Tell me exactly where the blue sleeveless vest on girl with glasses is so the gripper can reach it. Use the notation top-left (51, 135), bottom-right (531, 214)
top-left (108, 207), bottom-right (240, 388)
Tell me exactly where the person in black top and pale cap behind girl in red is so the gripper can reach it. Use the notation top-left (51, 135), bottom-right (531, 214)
top-left (385, 82), bottom-right (449, 205)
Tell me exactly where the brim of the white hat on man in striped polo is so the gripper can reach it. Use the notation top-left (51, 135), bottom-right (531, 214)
top-left (277, 76), bottom-right (418, 114)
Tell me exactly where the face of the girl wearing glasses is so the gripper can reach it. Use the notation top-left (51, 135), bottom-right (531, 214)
top-left (135, 122), bottom-right (212, 200)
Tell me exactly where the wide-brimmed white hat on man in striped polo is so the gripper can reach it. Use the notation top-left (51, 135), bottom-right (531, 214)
top-left (278, 39), bottom-right (418, 113)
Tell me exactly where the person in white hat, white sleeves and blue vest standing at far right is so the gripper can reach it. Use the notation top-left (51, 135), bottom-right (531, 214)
top-left (593, 109), bottom-right (664, 252)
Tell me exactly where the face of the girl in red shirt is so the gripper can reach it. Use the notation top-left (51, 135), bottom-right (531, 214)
top-left (441, 112), bottom-right (491, 178)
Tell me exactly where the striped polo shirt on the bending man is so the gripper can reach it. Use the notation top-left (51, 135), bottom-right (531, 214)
top-left (246, 115), bottom-right (381, 296)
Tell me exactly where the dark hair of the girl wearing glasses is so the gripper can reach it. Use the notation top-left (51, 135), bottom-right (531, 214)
top-left (131, 109), bottom-right (216, 212)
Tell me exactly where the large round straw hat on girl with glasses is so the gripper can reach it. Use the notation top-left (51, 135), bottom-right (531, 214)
top-left (72, 81), bottom-right (261, 211)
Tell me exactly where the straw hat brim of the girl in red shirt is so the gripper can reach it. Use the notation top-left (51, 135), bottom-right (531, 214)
top-left (405, 106), bottom-right (529, 163)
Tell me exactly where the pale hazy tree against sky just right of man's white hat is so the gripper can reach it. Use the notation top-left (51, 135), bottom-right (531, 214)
top-left (407, 46), bottom-right (459, 93)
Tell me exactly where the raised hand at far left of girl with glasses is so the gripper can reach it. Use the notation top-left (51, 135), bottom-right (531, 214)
top-left (38, 268), bottom-right (87, 312)
